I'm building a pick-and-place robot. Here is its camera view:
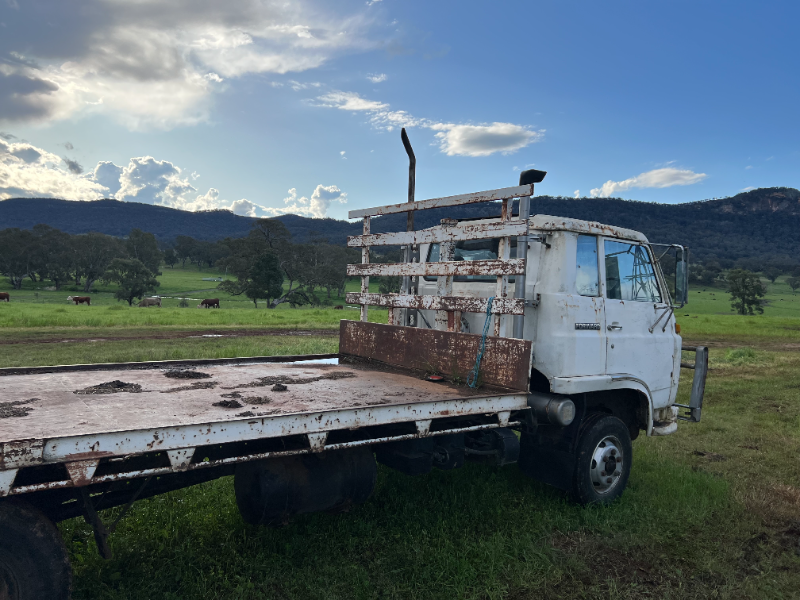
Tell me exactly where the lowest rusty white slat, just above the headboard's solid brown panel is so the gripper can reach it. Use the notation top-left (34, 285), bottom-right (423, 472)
top-left (345, 292), bottom-right (525, 315)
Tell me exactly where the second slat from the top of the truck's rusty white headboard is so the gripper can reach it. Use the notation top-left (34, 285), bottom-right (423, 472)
top-left (347, 221), bottom-right (528, 248)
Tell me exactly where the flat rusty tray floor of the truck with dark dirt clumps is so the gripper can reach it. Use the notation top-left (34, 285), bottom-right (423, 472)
top-left (0, 359), bottom-right (486, 443)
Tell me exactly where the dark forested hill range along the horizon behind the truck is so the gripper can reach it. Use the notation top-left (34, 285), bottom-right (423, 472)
top-left (0, 188), bottom-right (800, 262)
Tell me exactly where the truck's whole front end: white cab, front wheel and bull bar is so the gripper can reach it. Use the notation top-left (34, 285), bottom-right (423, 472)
top-left (414, 204), bottom-right (708, 503)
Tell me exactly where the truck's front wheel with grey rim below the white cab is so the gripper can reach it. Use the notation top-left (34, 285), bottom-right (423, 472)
top-left (572, 414), bottom-right (633, 506)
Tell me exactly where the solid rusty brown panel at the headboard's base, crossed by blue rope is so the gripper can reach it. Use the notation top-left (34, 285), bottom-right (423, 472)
top-left (339, 321), bottom-right (531, 391)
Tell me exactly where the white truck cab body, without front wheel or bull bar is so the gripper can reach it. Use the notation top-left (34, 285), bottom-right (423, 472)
top-left (416, 215), bottom-right (687, 437)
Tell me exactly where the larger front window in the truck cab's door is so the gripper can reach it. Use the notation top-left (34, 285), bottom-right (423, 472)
top-left (604, 240), bottom-right (661, 302)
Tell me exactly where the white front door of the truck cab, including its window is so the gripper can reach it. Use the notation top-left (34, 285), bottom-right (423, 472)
top-left (603, 239), bottom-right (675, 406)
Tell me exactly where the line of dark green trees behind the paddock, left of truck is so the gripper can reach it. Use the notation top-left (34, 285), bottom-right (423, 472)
top-left (0, 219), bottom-right (368, 308)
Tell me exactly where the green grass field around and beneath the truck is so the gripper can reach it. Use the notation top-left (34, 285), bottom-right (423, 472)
top-left (0, 269), bottom-right (800, 600)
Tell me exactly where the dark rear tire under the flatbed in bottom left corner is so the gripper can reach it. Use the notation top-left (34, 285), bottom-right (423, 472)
top-left (0, 500), bottom-right (72, 600)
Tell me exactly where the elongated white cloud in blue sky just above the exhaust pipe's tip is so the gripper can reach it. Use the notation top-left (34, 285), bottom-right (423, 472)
top-left (317, 90), bottom-right (544, 156)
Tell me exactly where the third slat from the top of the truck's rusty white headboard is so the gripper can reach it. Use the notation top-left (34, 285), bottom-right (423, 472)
top-left (347, 258), bottom-right (525, 277)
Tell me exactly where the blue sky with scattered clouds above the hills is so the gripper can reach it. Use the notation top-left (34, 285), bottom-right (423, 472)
top-left (0, 0), bottom-right (800, 219)
